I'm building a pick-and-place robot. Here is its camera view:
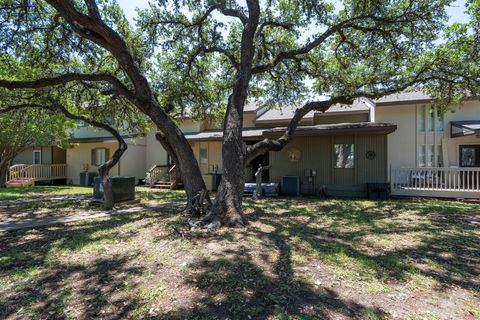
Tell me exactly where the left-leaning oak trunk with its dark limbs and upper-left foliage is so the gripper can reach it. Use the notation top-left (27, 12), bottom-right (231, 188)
top-left (0, 0), bottom-right (210, 215)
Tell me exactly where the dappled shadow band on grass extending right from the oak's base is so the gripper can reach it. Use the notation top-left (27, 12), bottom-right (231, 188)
top-left (251, 200), bottom-right (480, 292)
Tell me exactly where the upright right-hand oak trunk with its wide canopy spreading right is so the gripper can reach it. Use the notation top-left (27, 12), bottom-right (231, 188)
top-left (140, 0), bottom-right (480, 225)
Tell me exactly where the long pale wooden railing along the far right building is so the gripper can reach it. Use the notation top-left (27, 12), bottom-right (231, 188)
top-left (390, 168), bottom-right (480, 198)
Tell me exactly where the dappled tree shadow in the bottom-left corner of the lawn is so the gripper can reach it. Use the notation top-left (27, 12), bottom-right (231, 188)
top-left (0, 256), bottom-right (143, 319)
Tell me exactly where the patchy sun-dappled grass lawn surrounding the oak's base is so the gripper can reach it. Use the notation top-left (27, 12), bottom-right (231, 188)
top-left (0, 187), bottom-right (480, 320)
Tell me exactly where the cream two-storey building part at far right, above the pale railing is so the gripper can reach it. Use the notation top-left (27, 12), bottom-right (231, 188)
top-left (376, 92), bottom-right (480, 168)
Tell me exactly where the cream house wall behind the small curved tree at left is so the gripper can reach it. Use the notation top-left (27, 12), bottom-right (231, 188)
top-left (66, 139), bottom-right (146, 184)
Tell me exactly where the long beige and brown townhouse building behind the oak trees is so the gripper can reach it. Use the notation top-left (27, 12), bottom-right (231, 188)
top-left (6, 92), bottom-right (480, 197)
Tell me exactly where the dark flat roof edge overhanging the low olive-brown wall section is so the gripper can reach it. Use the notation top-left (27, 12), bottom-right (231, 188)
top-left (263, 122), bottom-right (397, 138)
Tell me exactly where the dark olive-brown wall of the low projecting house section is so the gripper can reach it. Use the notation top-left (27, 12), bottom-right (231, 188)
top-left (270, 134), bottom-right (387, 196)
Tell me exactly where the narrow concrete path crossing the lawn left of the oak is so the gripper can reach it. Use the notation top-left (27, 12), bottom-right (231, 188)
top-left (0, 202), bottom-right (183, 232)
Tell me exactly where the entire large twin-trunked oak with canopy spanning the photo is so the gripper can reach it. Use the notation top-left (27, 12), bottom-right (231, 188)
top-left (0, 0), bottom-right (479, 226)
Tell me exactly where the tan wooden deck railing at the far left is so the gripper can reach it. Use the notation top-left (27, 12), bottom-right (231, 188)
top-left (8, 163), bottom-right (67, 181)
